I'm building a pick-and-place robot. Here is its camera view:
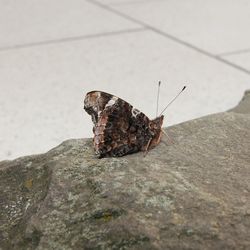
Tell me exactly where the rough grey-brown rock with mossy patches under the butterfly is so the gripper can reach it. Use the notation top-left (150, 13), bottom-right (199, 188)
top-left (0, 92), bottom-right (250, 249)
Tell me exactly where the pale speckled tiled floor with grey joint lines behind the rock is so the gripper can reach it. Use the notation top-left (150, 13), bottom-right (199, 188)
top-left (0, 0), bottom-right (250, 160)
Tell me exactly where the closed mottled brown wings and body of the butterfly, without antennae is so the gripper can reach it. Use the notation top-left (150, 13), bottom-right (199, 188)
top-left (84, 91), bottom-right (164, 158)
